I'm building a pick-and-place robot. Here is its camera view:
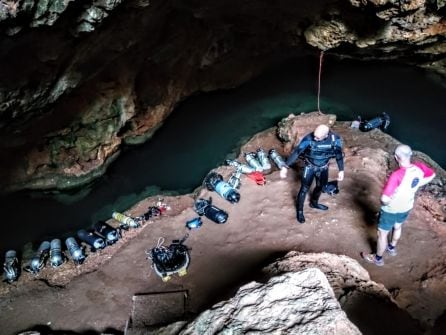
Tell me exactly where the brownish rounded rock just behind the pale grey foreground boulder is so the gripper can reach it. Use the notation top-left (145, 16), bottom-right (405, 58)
top-left (264, 251), bottom-right (421, 334)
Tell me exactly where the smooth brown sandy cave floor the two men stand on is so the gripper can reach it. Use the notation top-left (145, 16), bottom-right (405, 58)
top-left (0, 124), bottom-right (446, 334)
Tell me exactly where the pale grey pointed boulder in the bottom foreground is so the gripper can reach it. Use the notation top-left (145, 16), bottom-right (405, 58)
top-left (139, 268), bottom-right (361, 335)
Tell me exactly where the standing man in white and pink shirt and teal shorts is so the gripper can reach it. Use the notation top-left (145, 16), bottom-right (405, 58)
top-left (361, 144), bottom-right (435, 266)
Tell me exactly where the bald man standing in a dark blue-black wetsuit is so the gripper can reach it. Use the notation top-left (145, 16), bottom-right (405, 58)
top-left (280, 124), bottom-right (344, 223)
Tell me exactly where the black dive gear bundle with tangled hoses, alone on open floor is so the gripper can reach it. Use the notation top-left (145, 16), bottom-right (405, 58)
top-left (146, 235), bottom-right (190, 282)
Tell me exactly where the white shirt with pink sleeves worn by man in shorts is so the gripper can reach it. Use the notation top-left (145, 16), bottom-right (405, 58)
top-left (382, 162), bottom-right (434, 213)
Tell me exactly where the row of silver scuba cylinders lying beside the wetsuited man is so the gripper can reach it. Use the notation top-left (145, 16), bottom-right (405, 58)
top-left (226, 148), bottom-right (286, 174)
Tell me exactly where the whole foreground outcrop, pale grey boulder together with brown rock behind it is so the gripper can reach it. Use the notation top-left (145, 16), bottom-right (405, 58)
top-left (127, 251), bottom-right (422, 335)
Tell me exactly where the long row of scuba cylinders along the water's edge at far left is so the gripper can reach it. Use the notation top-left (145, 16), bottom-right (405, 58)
top-left (3, 212), bottom-right (140, 283)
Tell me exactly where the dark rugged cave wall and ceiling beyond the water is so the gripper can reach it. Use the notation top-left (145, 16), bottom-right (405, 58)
top-left (0, 0), bottom-right (446, 191)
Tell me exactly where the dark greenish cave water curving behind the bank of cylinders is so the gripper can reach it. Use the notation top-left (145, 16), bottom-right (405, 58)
top-left (0, 57), bottom-right (446, 252)
